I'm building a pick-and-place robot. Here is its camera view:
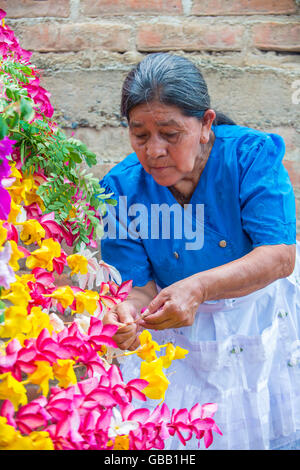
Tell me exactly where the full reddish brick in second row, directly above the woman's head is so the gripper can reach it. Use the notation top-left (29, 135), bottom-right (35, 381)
top-left (137, 23), bottom-right (244, 51)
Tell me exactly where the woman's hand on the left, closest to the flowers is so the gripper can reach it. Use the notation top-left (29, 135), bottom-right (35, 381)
top-left (102, 300), bottom-right (140, 351)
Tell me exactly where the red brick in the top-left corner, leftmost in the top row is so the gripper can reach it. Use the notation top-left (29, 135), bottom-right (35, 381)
top-left (0, 0), bottom-right (70, 18)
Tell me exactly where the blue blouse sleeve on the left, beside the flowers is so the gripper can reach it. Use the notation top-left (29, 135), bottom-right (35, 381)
top-left (100, 177), bottom-right (153, 286)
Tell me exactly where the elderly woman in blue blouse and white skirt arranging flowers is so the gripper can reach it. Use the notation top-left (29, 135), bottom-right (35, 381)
top-left (101, 53), bottom-right (300, 449)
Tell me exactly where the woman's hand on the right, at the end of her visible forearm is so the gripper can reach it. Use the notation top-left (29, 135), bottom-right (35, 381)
top-left (138, 278), bottom-right (203, 330)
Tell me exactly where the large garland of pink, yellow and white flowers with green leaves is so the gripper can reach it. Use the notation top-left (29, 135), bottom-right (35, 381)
top-left (0, 10), bottom-right (221, 450)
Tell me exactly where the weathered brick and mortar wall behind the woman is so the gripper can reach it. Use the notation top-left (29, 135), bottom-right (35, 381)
top-left (0, 0), bottom-right (300, 233)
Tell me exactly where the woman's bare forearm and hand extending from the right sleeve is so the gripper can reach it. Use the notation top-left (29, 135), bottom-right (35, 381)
top-left (139, 245), bottom-right (296, 330)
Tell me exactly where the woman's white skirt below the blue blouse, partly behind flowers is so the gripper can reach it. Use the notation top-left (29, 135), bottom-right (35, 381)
top-left (121, 243), bottom-right (300, 450)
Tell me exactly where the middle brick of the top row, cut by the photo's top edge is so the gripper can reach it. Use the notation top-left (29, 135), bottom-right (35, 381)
top-left (82, 0), bottom-right (182, 16)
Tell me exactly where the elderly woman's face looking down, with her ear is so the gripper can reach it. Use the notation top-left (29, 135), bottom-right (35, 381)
top-left (129, 101), bottom-right (215, 186)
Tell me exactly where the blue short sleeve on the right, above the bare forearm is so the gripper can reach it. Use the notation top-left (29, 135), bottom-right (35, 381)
top-left (238, 134), bottom-right (296, 247)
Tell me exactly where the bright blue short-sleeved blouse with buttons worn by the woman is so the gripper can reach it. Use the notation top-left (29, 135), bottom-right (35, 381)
top-left (101, 125), bottom-right (296, 288)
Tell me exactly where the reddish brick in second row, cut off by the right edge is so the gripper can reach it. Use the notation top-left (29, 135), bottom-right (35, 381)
top-left (252, 22), bottom-right (300, 52)
